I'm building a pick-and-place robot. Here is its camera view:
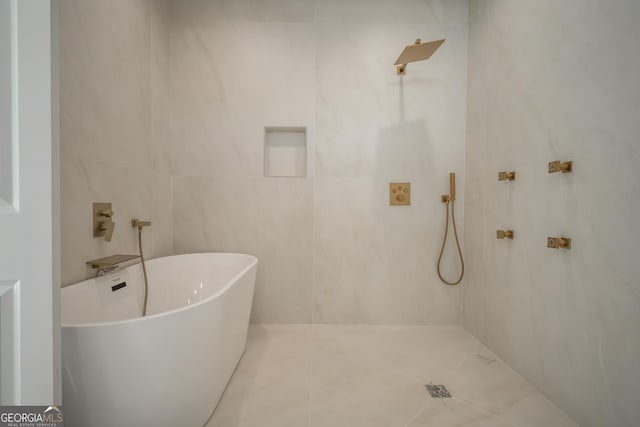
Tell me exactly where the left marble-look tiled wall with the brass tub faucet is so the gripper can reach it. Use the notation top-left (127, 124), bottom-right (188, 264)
top-left (59, 0), bottom-right (173, 284)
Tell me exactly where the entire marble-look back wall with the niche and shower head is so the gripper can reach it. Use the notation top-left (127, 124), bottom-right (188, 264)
top-left (169, 0), bottom-right (467, 324)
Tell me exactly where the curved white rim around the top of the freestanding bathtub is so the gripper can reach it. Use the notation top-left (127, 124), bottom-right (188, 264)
top-left (60, 252), bottom-right (258, 329)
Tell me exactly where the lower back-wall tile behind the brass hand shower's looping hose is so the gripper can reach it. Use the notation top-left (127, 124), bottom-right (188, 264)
top-left (314, 178), bottom-right (462, 324)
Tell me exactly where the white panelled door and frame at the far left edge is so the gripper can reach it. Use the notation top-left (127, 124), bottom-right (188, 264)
top-left (0, 0), bottom-right (60, 405)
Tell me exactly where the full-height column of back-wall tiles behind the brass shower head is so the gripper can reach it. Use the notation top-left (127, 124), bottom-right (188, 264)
top-left (314, 1), bottom-right (467, 324)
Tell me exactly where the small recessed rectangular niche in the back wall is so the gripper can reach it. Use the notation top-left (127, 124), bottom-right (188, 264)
top-left (264, 127), bottom-right (307, 177)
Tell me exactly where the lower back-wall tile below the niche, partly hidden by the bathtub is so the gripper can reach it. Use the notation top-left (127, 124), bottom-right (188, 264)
top-left (174, 178), bottom-right (313, 323)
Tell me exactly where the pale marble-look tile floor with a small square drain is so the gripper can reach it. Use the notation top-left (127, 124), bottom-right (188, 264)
top-left (205, 325), bottom-right (577, 427)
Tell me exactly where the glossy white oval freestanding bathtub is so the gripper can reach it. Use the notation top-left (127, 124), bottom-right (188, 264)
top-left (61, 253), bottom-right (258, 427)
